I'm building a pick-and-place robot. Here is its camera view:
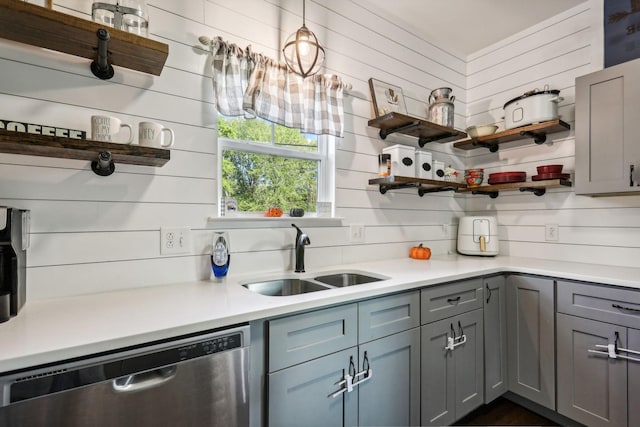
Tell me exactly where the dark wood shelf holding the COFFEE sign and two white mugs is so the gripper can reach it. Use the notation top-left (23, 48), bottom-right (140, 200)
top-left (0, 130), bottom-right (171, 166)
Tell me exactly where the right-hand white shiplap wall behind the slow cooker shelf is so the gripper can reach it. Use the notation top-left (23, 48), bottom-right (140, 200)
top-left (467, 0), bottom-right (640, 267)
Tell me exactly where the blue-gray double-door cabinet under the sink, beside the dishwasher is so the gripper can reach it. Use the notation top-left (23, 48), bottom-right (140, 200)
top-left (267, 291), bottom-right (420, 427)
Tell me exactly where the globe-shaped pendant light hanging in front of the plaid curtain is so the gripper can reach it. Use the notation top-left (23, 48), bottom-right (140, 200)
top-left (282, 0), bottom-right (324, 77)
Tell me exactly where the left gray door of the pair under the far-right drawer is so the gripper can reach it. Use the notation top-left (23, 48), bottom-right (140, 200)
top-left (557, 313), bottom-right (637, 427)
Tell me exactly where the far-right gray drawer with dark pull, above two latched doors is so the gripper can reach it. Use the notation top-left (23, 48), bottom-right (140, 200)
top-left (557, 280), bottom-right (640, 328)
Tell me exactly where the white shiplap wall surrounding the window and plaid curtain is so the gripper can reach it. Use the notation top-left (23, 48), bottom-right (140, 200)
top-left (0, 0), bottom-right (467, 301)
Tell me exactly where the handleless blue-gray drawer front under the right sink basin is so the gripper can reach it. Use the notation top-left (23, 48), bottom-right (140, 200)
top-left (358, 291), bottom-right (420, 343)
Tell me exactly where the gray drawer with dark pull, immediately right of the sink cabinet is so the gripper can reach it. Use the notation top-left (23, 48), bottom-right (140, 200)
top-left (421, 278), bottom-right (482, 324)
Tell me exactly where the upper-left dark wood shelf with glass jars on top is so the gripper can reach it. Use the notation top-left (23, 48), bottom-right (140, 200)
top-left (0, 0), bottom-right (169, 76)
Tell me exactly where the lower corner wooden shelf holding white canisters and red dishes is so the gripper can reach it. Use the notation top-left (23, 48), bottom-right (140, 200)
top-left (369, 175), bottom-right (571, 198)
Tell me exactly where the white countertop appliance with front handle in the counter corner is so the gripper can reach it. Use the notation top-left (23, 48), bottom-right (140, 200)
top-left (458, 216), bottom-right (500, 256)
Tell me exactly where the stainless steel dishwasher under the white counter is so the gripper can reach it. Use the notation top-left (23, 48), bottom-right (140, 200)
top-left (0, 325), bottom-right (250, 427)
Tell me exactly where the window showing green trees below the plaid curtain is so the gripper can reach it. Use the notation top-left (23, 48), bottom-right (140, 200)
top-left (218, 115), bottom-right (333, 213)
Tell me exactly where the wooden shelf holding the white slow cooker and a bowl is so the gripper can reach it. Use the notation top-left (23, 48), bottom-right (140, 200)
top-left (453, 119), bottom-right (571, 152)
